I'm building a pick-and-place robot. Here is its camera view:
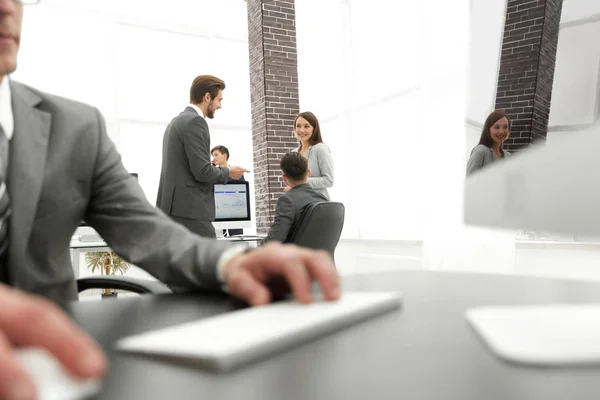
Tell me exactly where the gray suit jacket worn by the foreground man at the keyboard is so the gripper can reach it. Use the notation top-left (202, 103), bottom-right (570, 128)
top-left (7, 81), bottom-right (232, 303)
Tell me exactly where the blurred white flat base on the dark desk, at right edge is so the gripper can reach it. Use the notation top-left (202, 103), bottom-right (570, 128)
top-left (466, 304), bottom-right (600, 366)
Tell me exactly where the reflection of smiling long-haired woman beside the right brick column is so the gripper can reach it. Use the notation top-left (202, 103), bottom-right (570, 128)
top-left (467, 111), bottom-right (510, 176)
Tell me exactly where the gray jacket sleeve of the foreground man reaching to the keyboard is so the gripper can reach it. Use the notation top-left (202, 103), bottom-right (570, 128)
top-left (85, 112), bottom-right (229, 289)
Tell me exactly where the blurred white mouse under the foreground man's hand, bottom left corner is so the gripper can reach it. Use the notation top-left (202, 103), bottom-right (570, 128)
top-left (16, 348), bottom-right (100, 400)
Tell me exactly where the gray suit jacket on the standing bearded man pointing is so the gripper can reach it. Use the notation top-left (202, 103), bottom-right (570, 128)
top-left (156, 107), bottom-right (229, 221)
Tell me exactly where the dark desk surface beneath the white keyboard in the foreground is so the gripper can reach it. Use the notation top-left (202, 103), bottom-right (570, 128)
top-left (71, 271), bottom-right (600, 400)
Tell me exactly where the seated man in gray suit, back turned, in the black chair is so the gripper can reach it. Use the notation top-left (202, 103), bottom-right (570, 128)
top-left (263, 152), bottom-right (327, 243)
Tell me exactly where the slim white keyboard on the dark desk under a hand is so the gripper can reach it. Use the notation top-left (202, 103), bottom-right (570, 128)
top-left (117, 292), bottom-right (401, 371)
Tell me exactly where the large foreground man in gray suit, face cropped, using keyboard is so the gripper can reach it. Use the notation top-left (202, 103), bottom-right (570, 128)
top-left (0, 0), bottom-right (339, 399)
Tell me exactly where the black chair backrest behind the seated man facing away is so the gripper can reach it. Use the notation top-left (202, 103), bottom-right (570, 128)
top-left (288, 201), bottom-right (345, 257)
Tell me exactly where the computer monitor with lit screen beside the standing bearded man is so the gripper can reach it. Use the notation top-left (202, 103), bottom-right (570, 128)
top-left (213, 182), bottom-right (252, 235)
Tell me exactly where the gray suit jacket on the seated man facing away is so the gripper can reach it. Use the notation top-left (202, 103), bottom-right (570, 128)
top-left (262, 183), bottom-right (328, 243)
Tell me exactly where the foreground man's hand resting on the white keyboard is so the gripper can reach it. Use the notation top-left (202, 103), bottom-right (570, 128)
top-left (224, 242), bottom-right (340, 306)
